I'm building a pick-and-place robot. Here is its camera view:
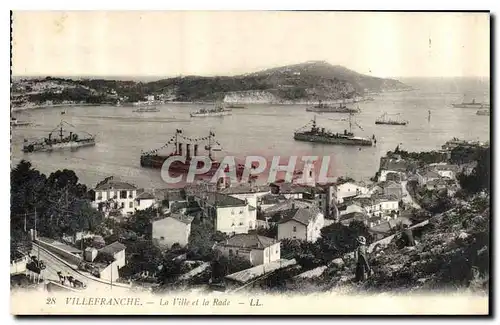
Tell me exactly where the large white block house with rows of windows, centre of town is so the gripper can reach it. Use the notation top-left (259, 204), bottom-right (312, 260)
top-left (195, 192), bottom-right (257, 234)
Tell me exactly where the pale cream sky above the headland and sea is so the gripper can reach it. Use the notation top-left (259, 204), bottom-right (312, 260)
top-left (12, 11), bottom-right (490, 78)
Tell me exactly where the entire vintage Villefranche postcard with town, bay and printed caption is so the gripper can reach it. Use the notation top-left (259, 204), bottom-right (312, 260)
top-left (10, 11), bottom-right (491, 315)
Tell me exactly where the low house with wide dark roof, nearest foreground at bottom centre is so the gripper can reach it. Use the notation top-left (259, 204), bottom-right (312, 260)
top-left (215, 234), bottom-right (281, 266)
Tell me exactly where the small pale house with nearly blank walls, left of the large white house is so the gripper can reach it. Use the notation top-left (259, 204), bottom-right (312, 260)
top-left (151, 213), bottom-right (193, 248)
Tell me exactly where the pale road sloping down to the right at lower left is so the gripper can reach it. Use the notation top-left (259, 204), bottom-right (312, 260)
top-left (31, 245), bottom-right (128, 292)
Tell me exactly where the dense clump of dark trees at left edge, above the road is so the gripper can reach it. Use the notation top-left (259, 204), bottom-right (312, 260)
top-left (10, 160), bottom-right (103, 248)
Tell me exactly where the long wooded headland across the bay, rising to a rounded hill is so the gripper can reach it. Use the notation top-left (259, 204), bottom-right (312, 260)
top-left (11, 61), bottom-right (410, 106)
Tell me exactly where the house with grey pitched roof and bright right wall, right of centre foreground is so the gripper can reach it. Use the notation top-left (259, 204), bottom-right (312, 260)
top-left (278, 207), bottom-right (325, 242)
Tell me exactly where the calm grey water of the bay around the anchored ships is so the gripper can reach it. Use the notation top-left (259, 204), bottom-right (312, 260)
top-left (11, 79), bottom-right (490, 188)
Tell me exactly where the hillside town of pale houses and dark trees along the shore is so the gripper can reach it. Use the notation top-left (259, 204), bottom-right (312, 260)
top-left (11, 139), bottom-right (490, 292)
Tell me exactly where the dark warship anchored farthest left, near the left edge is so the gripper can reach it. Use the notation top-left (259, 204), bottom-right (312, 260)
top-left (23, 121), bottom-right (95, 152)
